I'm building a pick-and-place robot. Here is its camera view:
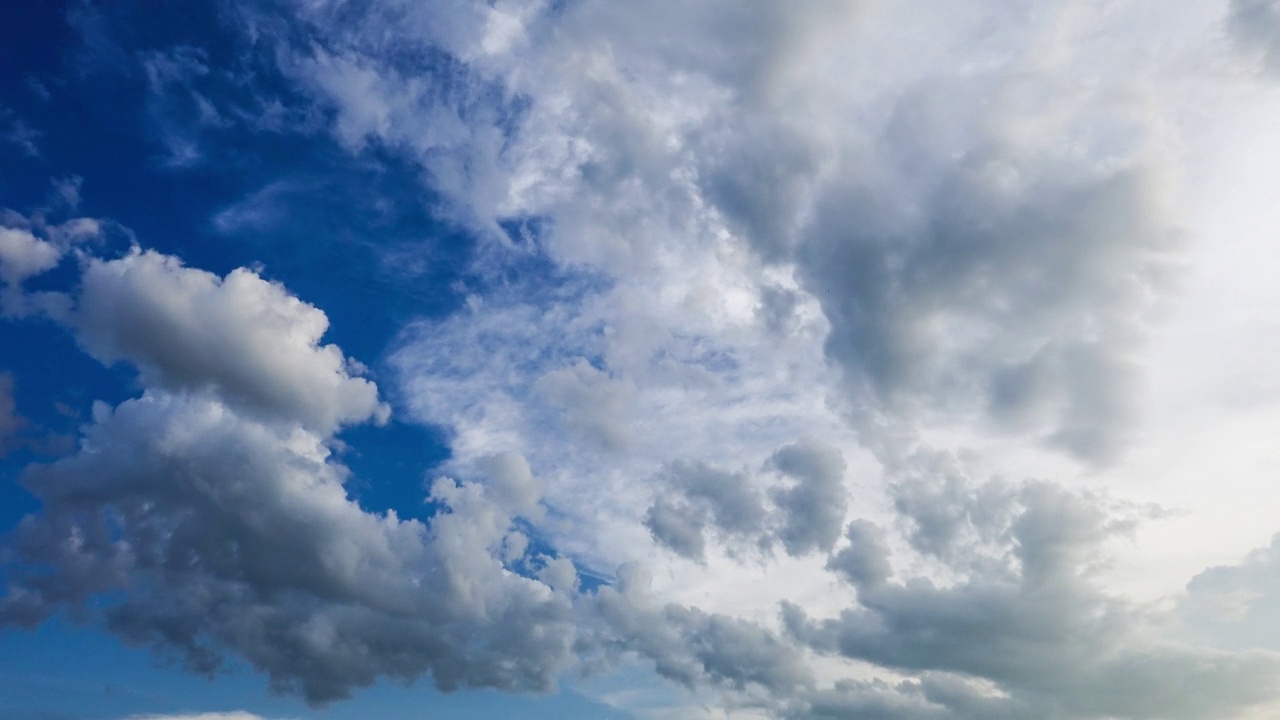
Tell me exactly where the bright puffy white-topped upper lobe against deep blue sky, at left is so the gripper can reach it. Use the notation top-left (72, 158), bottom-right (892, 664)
top-left (72, 250), bottom-right (389, 434)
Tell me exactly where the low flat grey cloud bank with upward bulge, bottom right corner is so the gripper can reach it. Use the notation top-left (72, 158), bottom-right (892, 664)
top-left (783, 471), bottom-right (1280, 717)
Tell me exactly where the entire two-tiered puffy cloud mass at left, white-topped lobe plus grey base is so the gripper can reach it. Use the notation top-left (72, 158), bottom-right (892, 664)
top-left (0, 245), bottom-right (576, 702)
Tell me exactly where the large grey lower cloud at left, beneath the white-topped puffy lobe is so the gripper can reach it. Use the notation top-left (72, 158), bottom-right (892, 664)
top-left (3, 392), bottom-right (572, 702)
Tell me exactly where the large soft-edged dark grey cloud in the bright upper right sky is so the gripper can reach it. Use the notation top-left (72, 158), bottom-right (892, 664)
top-left (797, 86), bottom-right (1178, 461)
